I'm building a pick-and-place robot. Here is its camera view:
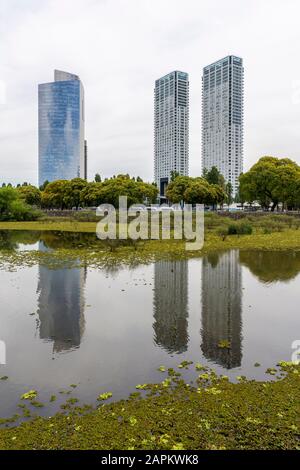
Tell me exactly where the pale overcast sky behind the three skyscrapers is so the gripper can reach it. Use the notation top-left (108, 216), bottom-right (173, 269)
top-left (0, 0), bottom-right (300, 184)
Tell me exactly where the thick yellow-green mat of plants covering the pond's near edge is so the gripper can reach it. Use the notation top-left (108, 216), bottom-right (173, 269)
top-left (0, 363), bottom-right (300, 450)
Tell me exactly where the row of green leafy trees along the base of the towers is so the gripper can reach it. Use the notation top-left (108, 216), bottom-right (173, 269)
top-left (0, 157), bottom-right (300, 220)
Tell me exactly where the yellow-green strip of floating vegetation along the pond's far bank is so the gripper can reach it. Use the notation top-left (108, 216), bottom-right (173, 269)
top-left (0, 226), bottom-right (300, 274)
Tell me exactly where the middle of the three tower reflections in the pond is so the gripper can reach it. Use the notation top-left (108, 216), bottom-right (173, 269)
top-left (153, 261), bottom-right (189, 353)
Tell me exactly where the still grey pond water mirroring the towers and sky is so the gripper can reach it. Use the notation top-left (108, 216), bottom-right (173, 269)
top-left (0, 231), bottom-right (300, 417)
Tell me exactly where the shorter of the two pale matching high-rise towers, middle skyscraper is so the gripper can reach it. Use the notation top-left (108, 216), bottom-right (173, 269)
top-left (154, 71), bottom-right (189, 200)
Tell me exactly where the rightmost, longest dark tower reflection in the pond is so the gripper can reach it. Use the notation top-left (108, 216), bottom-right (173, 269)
top-left (201, 251), bottom-right (242, 369)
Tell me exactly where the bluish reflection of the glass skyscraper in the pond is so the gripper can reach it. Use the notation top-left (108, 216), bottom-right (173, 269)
top-left (38, 242), bottom-right (86, 352)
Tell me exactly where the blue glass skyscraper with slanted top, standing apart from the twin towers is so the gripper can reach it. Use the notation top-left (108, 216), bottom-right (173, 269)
top-left (39, 70), bottom-right (85, 185)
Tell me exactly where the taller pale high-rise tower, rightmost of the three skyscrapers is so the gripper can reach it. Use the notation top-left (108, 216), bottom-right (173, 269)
top-left (202, 55), bottom-right (244, 195)
